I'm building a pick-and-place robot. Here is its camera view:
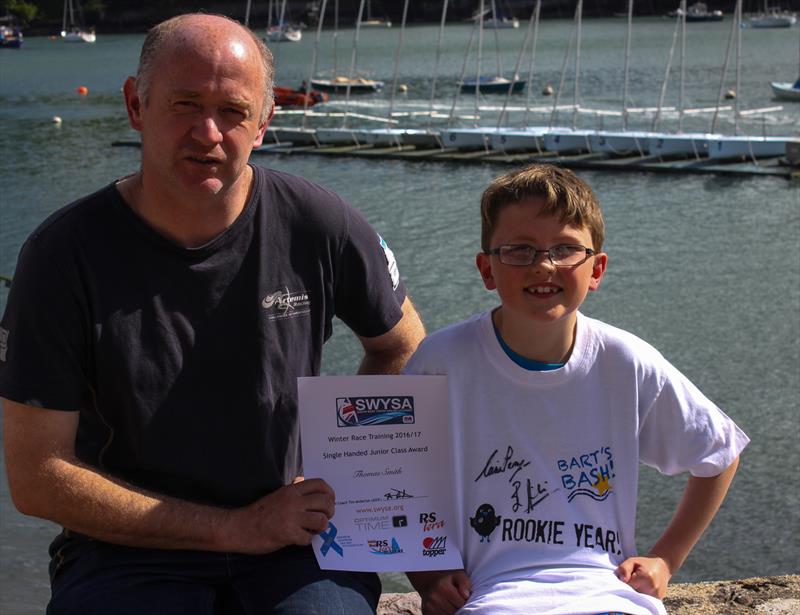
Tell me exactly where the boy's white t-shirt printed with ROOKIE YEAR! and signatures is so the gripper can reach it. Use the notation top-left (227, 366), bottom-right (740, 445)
top-left (405, 312), bottom-right (749, 615)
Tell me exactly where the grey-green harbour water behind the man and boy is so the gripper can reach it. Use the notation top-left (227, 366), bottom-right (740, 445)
top-left (0, 19), bottom-right (800, 615)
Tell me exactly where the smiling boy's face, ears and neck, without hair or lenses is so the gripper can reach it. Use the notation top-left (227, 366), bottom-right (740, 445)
top-left (476, 199), bottom-right (608, 362)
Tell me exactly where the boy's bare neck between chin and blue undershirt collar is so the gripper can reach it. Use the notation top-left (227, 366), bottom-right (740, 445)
top-left (492, 306), bottom-right (577, 363)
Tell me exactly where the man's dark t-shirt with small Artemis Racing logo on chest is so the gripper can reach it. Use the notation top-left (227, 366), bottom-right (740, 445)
top-left (0, 167), bottom-right (405, 506)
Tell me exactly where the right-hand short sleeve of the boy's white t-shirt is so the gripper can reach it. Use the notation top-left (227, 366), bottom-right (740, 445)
top-left (639, 365), bottom-right (750, 477)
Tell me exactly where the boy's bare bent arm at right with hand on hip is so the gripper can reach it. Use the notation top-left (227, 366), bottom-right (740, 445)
top-left (617, 457), bottom-right (739, 599)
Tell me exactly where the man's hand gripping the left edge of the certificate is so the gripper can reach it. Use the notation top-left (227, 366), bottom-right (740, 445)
top-left (220, 478), bottom-right (335, 554)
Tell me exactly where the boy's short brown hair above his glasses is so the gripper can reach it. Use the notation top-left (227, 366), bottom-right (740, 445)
top-left (481, 164), bottom-right (605, 252)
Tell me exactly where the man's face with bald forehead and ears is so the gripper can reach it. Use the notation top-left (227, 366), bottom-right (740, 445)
top-left (128, 23), bottom-right (267, 198)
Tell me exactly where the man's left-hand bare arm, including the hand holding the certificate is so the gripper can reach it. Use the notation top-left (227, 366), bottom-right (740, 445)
top-left (3, 400), bottom-right (334, 553)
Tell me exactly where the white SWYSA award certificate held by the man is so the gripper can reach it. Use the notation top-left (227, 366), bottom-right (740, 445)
top-left (298, 376), bottom-right (463, 572)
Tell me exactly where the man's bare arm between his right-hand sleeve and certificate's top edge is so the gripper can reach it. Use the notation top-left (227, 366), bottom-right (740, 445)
top-left (358, 297), bottom-right (425, 374)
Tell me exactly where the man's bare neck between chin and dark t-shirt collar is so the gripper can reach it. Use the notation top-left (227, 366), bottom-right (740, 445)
top-left (117, 166), bottom-right (253, 248)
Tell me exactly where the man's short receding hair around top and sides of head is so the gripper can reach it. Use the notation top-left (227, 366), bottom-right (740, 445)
top-left (136, 13), bottom-right (275, 124)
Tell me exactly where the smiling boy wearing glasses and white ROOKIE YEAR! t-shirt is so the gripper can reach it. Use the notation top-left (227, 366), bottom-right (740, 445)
top-left (405, 165), bottom-right (749, 615)
